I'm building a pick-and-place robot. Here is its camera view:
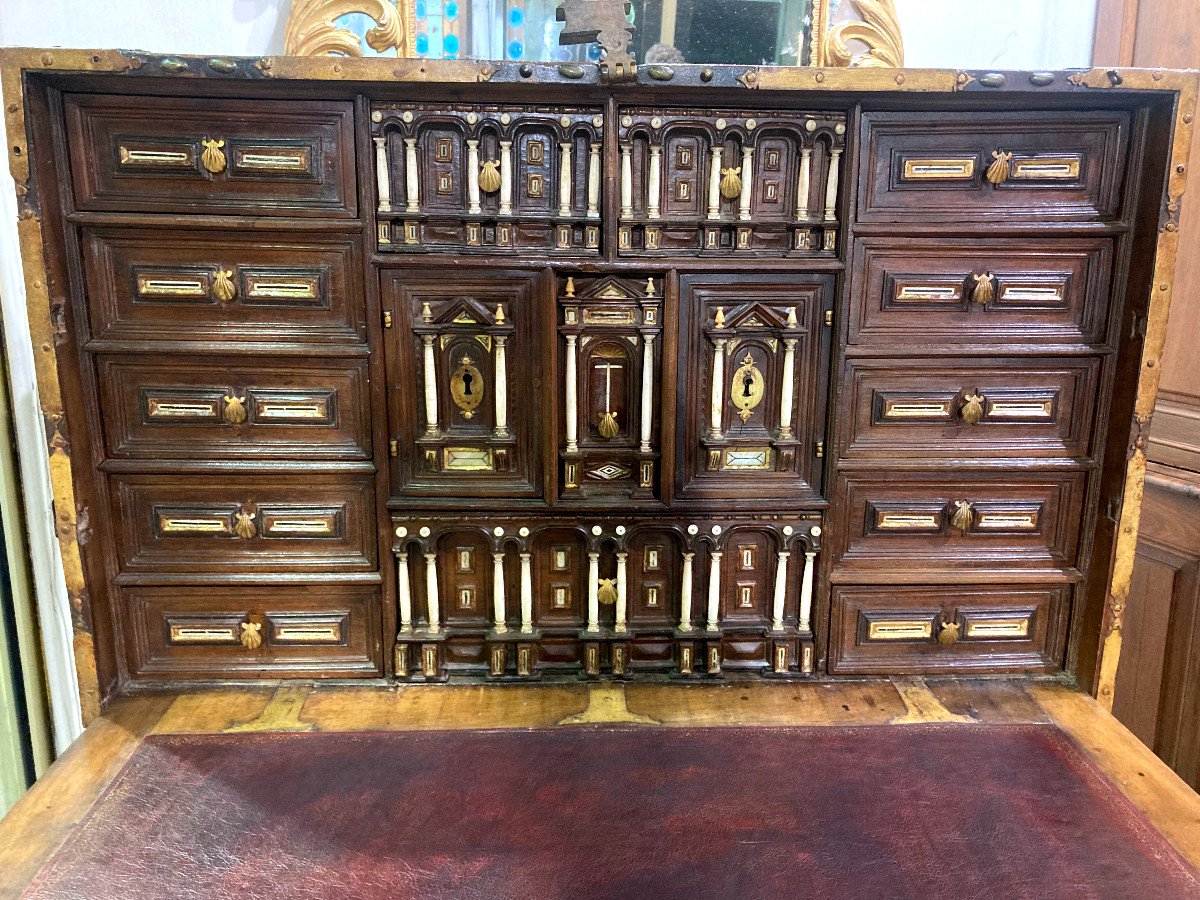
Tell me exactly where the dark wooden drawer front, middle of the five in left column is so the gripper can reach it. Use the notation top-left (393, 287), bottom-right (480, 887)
top-left (96, 355), bottom-right (371, 460)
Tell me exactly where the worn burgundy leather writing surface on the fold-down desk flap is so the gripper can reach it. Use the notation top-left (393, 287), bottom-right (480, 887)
top-left (26, 725), bottom-right (1200, 900)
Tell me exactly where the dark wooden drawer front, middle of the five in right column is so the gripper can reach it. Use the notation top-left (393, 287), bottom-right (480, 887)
top-left (841, 356), bottom-right (1100, 458)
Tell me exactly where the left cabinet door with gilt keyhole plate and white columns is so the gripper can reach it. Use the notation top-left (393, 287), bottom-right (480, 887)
top-left (384, 270), bottom-right (552, 498)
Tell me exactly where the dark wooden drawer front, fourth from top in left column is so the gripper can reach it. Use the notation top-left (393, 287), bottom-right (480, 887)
top-left (112, 473), bottom-right (377, 575)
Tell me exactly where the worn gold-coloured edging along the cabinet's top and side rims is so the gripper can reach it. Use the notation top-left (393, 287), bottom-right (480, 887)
top-left (0, 47), bottom-right (1200, 725)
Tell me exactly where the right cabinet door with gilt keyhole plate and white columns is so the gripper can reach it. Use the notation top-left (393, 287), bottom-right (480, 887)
top-left (676, 275), bottom-right (834, 504)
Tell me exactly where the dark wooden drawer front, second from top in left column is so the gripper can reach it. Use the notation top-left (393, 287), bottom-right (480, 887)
top-left (84, 229), bottom-right (366, 342)
